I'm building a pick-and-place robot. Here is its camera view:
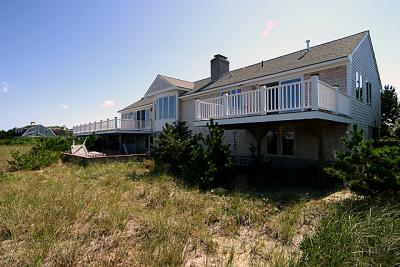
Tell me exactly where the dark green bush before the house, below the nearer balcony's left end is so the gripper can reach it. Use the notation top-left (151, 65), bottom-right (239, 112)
top-left (155, 121), bottom-right (232, 188)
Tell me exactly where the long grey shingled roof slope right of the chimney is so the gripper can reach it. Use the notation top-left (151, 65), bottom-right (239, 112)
top-left (185, 31), bottom-right (368, 95)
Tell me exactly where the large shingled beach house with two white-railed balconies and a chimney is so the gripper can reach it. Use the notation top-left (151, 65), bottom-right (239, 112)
top-left (73, 31), bottom-right (382, 170)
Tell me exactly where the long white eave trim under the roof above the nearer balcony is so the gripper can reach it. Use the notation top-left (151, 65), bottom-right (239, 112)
top-left (179, 57), bottom-right (349, 99)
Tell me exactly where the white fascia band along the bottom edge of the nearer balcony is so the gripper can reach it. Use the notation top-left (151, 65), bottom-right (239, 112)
top-left (194, 111), bottom-right (353, 126)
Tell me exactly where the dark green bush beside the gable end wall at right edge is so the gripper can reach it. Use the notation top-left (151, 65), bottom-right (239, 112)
top-left (326, 126), bottom-right (400, 195)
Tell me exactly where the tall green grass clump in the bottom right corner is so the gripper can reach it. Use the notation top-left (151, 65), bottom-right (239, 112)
top-left (298, 198), bottom-right (400, 266)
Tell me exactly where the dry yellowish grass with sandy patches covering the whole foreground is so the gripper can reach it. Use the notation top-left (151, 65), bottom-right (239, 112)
top-left (0, 146), bottom-right (400, 266)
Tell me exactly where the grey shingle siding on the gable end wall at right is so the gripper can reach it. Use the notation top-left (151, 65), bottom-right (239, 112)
top-left (350, 35), bottom-right (382, 134)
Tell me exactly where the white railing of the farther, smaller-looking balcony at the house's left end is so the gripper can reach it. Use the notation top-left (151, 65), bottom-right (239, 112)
top-left (73, 118), bottom-right (151, 134)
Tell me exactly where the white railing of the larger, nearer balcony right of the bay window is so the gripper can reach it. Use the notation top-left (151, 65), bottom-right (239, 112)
top-left (195, 76), bottom-right (350, 120)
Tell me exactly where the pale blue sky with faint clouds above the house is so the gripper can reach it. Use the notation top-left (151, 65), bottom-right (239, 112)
top-left (0, 0), bottom-right (400, 130)
